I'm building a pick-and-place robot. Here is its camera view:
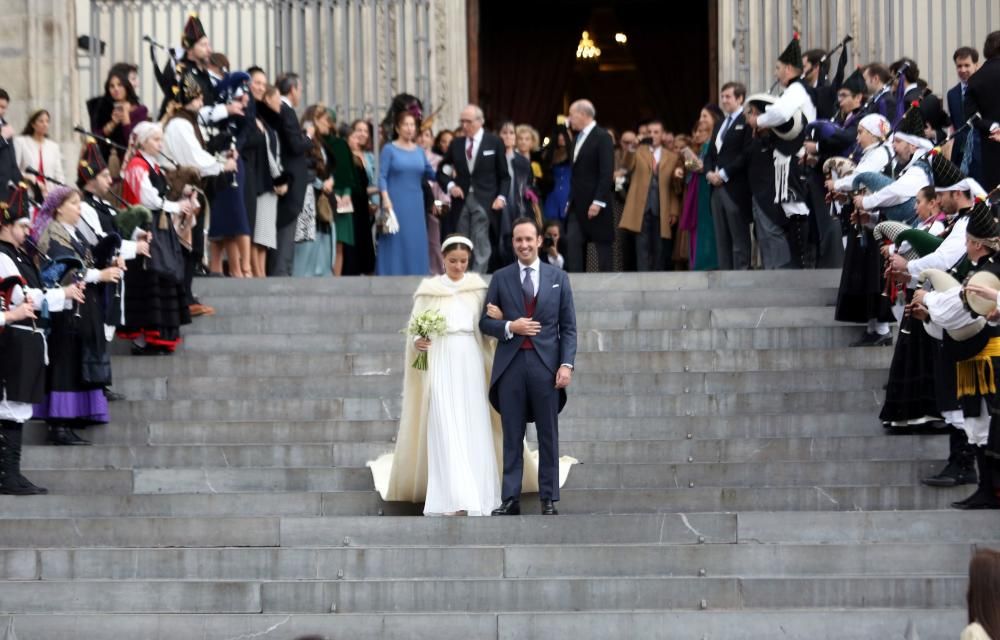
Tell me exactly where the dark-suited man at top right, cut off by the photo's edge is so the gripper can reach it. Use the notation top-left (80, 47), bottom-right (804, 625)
top-left (965, 31), bottom-right (1000, 191)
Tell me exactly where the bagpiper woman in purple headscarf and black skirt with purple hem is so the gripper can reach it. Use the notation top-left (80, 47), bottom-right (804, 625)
top-left (32, 187), bottom-right (125, 445)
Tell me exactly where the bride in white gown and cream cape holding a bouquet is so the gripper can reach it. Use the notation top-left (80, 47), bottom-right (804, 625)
top-left (368, 235), bottom-right (576, 516)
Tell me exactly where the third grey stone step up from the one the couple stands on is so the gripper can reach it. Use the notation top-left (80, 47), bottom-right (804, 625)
top-left (23, 430), bottom-right (948, 476)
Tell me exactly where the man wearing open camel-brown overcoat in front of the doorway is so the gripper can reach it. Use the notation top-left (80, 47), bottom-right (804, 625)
top-left (619, 120), bottom-right (684, 271)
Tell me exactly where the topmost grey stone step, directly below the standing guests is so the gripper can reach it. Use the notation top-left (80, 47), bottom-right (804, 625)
top-left (194, 269), bottom-right (841, 297)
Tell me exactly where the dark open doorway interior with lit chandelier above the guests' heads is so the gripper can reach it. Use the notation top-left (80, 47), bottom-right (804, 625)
top-left (470, 0), bottom-right (715, 138)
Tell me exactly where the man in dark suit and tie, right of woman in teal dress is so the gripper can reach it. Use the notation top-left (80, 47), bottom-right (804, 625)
top-left (705, 82), bottom-right (753, 270)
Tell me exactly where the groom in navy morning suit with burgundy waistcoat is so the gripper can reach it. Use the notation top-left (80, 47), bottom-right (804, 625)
top-left (479, 218), bottom-right (576, 516)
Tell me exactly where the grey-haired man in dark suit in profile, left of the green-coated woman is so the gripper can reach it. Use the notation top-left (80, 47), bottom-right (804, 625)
top-left (267, 73), bottom-right (313, 276)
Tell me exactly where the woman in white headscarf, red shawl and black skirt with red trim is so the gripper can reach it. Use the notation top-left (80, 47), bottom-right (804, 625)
top-left (118, 122), bottom-right (200, 355)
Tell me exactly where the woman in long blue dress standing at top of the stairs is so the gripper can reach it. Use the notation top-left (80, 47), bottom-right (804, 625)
top-left (375, 111), bottom-right (434, 276)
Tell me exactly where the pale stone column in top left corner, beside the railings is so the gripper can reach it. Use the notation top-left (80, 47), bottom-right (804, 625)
top-left (0, 0), bottom-right (82, 182)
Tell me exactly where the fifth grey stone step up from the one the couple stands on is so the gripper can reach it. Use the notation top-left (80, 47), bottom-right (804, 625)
top-left (56, 390), bottom-right (882, 429)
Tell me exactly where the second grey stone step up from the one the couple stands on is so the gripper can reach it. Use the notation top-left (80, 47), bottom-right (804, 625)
top-left (121, 456), bottom-right (944, 494)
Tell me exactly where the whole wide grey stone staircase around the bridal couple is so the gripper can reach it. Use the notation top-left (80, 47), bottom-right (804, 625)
top-left (0, 271), bottom-right (1000, 640)
